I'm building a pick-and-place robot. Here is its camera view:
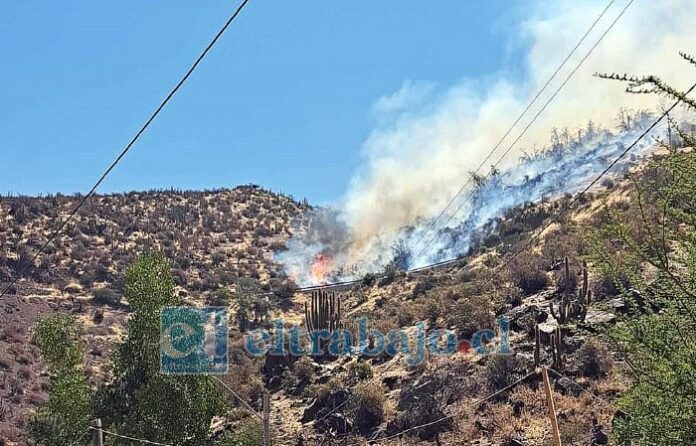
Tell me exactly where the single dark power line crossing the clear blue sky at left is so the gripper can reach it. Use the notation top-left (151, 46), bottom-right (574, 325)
top-left (0, 0), bottom-right (254, 298)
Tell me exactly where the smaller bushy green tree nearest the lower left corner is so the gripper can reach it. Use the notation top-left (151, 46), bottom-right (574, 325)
top-left (28, 315), bottom-right (92, 446)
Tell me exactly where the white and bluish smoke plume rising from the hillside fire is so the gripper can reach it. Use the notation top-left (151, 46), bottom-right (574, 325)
top-left (277, 0), bottom-right (696, 285)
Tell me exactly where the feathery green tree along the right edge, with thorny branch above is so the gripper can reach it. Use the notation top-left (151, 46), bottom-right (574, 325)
top-left (594, 55), bottom-right (696, 446)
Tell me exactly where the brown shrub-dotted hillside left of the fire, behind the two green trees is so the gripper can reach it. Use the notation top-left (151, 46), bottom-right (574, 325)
top-left (0, 186), bottom-right (308, 444)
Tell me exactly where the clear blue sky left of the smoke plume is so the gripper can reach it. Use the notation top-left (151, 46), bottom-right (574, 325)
top-left (0, 0), bottom-right (521, 203)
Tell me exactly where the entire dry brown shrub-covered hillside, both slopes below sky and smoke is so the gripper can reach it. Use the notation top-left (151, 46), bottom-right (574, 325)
top-left (0, 152), bottom-right (688, 446)
